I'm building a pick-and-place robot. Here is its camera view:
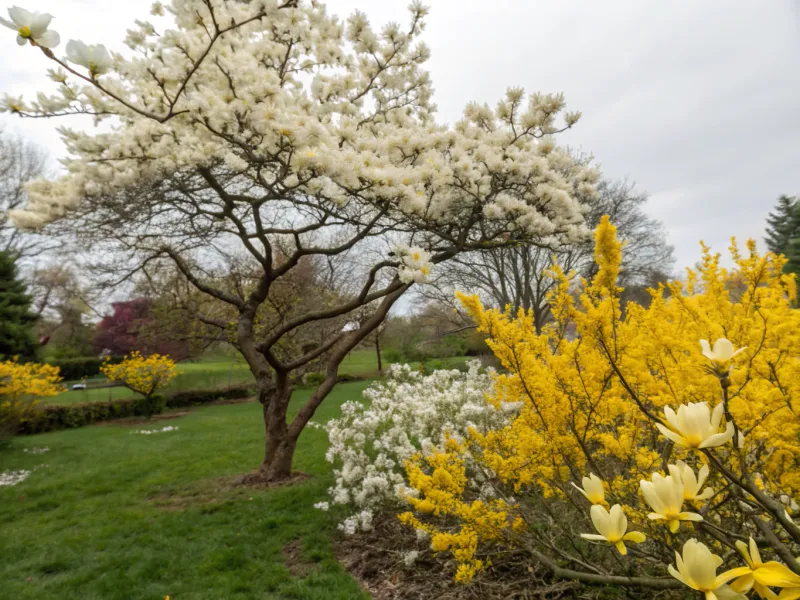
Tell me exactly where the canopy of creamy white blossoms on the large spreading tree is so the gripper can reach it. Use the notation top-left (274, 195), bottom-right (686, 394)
top-left (6, 0), bottom-right (598, 255)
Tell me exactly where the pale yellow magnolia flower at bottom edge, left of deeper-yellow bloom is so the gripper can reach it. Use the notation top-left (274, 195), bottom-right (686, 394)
top-left (667, 539), bottom-right (750, 600)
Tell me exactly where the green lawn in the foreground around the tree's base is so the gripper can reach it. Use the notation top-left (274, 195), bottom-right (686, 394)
top-left (0, 382), bottom-right (376, 600)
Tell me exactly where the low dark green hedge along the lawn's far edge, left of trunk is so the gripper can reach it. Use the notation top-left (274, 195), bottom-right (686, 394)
top-left (18, 385), bottom-right (254, 435)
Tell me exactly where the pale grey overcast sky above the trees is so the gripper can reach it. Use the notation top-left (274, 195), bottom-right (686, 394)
top-left (0, 0), bottom-right (800, 267)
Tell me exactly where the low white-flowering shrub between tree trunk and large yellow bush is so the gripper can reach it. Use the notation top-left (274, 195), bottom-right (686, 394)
top-left (326, 361), bottom-right (520, 534)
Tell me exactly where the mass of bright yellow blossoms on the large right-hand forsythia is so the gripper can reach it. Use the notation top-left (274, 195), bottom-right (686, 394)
top-left (400, 217), bottom-right (800, 580)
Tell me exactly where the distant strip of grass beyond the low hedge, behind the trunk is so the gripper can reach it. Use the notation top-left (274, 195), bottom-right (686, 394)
top-left (48, 350), bottom-right (466, 404)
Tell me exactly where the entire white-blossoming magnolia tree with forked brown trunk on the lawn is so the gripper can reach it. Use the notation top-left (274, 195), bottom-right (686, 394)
top-left (3, 0), bottom-right (597, 480)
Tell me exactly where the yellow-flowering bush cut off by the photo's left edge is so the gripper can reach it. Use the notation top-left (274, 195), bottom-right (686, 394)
top-left (0, 360), bottom-right (62, 441)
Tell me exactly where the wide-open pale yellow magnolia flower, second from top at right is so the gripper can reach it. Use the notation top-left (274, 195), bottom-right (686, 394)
top-left (656, 402), bottom-right (733, 448)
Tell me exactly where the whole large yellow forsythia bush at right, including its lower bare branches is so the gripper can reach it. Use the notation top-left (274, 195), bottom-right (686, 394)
top-left (400, 218), bottom-right (800, 600)
